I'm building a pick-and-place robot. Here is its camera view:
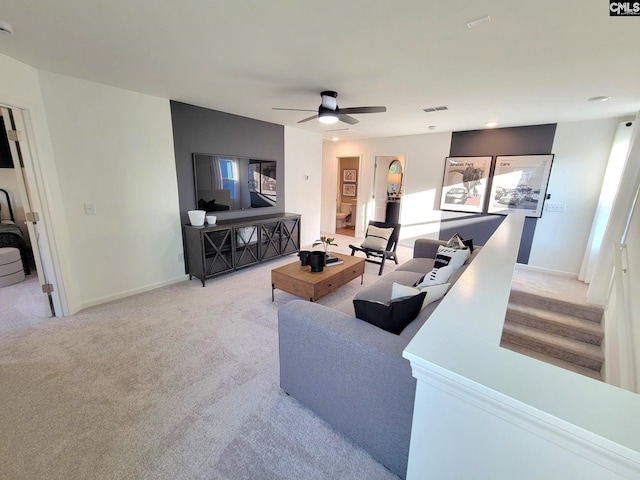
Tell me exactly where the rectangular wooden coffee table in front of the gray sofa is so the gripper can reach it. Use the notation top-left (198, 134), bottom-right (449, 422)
top-left (271, 253), bottom-right (364, 302)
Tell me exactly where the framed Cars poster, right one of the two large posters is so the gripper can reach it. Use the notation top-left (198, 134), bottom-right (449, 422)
top-left (488, 154), bottom-right (553, 217)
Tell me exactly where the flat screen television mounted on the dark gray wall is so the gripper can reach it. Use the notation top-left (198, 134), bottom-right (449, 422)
top-left (193, 153), bottom-right (277, 212)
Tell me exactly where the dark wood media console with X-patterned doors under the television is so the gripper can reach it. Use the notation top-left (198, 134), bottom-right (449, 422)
top-left (184, 213), bottom-right (300, 287)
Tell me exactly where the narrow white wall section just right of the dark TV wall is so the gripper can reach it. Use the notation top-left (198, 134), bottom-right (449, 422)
top-left (284, 127), bottom-right (322, 246)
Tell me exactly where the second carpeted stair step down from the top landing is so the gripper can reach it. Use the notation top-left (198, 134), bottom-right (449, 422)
top-left (506, 303), bottom-right (604, 345)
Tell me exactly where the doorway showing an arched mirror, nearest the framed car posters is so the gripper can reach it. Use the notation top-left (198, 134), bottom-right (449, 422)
top-left (372, 155), bottom-right (405, 223)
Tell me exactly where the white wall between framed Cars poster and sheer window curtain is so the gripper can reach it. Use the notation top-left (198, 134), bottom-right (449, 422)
top-left (529, 118), bottom-right (621, 276)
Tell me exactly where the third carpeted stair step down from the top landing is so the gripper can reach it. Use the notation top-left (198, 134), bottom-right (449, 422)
top-left (502, 321), bottom-right (604, 372)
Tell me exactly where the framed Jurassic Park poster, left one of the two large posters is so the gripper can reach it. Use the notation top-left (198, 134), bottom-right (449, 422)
top-left (440, 156), bottom-right (493, 213)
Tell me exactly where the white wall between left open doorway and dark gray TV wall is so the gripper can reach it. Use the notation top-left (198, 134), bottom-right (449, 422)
top-left (39, 71), bottom-right (184, 313)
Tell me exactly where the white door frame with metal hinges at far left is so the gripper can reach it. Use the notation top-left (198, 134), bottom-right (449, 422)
top-left (0, 102), bottom-right (69, 317)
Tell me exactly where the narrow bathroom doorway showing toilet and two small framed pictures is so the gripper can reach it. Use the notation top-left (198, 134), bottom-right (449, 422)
top-left (336, 157), bottom-right (360, 237)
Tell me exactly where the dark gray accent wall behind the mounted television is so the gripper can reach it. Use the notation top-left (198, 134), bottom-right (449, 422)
top-left (170, 100), bottom-right (284, 223)
